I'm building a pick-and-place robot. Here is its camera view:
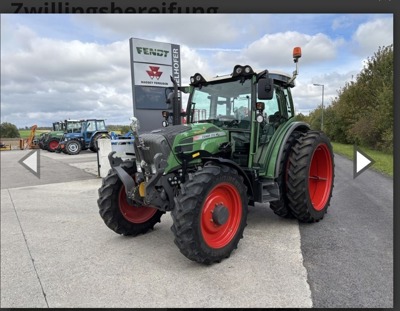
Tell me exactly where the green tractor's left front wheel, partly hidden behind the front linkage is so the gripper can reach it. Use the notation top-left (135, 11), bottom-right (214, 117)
top-left (97, 166), bottom-right (165, 236)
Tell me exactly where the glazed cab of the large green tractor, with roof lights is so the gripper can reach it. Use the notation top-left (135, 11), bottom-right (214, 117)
top-left (181, 65), bottom-right (300, 178)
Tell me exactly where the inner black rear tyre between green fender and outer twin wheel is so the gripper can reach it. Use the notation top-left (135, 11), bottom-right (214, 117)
top-left (269, 131), bottom-right (301, 218)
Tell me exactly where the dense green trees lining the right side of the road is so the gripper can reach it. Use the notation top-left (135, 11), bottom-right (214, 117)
top-left (309, 45), bottom-right (394, 151)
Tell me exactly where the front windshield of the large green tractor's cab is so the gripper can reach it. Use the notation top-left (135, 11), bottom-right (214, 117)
top-left (190, 79), bottom-right (251, 128)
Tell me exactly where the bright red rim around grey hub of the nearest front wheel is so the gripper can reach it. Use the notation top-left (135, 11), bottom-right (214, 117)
top-left (201, 183), bottom-right (242, 248)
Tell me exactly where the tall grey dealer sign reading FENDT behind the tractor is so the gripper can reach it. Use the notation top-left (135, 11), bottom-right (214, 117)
top-left (129, 38), bottom-right (181, 131)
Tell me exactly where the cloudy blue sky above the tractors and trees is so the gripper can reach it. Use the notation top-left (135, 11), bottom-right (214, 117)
top-left (1, 13), bottom-right (393, 128)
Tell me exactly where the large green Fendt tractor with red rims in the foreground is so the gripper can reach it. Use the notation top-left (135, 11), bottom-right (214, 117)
top-left (97, 48), bottom-right (334, 264)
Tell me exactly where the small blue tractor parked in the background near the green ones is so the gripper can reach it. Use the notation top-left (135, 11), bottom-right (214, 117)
top-left (58, 119), bottom-right (111, 155)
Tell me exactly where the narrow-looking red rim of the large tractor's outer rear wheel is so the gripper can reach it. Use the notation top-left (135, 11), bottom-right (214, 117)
top-left (308, 144), bottom-right (333, 211)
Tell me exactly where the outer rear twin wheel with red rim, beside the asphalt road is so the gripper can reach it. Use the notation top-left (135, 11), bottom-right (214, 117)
top-left (287, 131), bottom-right (335, 222)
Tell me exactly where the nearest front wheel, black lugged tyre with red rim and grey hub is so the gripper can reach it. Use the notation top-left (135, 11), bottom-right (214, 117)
top-left (171, 164), bottom-right (248, 264)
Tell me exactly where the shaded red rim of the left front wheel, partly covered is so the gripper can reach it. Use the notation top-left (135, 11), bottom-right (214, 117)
top-left (118, 186), bottom-right (157, 224)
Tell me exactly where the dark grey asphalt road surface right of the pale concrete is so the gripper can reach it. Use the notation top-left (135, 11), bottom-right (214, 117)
top-left (300, 155), bottom-right (394, 308)
